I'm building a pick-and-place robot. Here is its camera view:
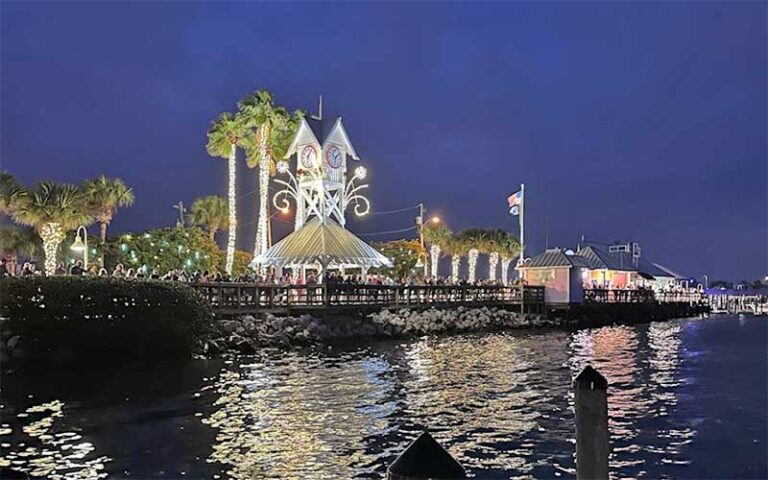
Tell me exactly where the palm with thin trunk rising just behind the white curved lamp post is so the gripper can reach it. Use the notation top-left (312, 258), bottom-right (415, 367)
top-left (83, 175), bottom-right (136, 268)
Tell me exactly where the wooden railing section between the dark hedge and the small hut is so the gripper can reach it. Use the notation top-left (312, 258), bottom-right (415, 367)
top-left (190, 283), bottom-right (544, 313)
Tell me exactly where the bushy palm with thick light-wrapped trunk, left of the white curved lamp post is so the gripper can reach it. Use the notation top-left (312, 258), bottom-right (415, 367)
top-left (13, 182), bottom-right (93, 275)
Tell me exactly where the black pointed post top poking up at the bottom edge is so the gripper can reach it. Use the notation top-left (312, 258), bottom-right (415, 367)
top-left (387, 432), bottom-right (467, 480)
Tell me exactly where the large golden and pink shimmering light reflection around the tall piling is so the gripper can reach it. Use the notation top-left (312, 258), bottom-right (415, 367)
top-left (196, 323), bottom-right (695, 478)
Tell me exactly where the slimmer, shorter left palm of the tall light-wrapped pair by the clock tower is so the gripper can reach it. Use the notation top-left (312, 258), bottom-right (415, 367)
top-left (206, 112), bottom-right (245, 275)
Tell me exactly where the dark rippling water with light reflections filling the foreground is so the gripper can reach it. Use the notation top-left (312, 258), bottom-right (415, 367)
top-left (0, 316), bottom-right (768, 479)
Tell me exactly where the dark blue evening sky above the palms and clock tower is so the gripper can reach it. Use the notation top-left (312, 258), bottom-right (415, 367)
top-left (0, 2), bottom-right (768, 280)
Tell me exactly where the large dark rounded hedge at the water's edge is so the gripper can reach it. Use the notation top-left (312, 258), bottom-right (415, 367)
top-left (0, 277), bottom-right (213, 359)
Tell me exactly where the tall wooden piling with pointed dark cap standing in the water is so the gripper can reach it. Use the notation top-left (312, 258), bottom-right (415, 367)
top-left (573, 365), bottom-right (610, 480)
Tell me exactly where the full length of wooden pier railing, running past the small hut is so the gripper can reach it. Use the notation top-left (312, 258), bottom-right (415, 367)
top-left (190, 283), bottom-right (708, 318)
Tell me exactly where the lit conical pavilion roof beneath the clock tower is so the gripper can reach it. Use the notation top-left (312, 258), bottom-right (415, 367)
top-left (262, 217), bottom-right (392, 267)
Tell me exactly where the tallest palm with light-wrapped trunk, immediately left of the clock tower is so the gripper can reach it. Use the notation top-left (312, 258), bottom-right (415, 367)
top-left (237, 90), bottom-right (300, 270)
